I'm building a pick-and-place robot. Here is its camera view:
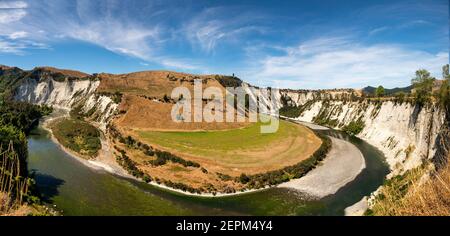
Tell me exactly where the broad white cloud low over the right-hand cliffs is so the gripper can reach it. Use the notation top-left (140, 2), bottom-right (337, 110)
top-left (245, 37), bottom-right (449, 88)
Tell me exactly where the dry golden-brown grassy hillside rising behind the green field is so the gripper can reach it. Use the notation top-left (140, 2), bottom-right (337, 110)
top-left (103, 71), bottom-right (248, 130)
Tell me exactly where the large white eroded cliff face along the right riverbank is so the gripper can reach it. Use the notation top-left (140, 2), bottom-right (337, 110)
top-left (281, 89), bottom-right (446, 176)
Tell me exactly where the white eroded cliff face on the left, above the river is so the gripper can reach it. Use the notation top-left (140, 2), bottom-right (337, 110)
top-left (15, 78), bottom-right (118, 129)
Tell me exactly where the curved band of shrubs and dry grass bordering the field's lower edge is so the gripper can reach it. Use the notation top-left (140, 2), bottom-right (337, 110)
top-left (107, 121), bottom-right (331, 194)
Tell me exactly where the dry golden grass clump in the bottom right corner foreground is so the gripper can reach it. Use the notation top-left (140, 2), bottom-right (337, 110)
top-left (372, 158), bottom-right (450, 216)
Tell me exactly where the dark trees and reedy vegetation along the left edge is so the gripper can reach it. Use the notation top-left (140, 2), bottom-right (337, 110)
top-left (0, 73), bottom-right (52, 216)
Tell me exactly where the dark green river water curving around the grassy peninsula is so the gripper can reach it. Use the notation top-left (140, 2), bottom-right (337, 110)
top-left (29, 128), bottom-right (388, 215)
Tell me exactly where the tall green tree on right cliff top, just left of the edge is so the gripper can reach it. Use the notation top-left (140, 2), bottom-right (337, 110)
top-left (411, 69), bottom-right (436, 106)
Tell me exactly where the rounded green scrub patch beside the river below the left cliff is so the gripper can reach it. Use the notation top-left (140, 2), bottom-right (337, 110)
top-left (50, 118), bottom-right (101, 158)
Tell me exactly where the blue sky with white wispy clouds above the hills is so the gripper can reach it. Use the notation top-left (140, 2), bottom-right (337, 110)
top-left (0, 0), bottom-right (449, 89)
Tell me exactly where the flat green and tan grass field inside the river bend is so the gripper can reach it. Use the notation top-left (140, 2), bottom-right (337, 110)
top-left (137, 120), bottom-right (320, 171)
